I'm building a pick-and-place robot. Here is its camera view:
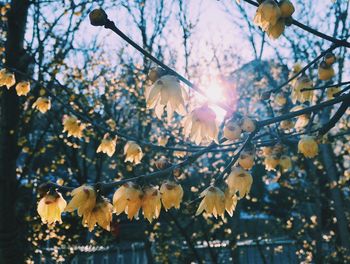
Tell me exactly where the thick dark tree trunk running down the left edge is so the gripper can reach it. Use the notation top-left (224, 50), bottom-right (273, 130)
top-left (0, 0), bottom-right (29, 264)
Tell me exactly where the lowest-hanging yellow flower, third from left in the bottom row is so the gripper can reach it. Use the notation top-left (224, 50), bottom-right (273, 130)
top-left (83, 197), bottom-right (113, 232)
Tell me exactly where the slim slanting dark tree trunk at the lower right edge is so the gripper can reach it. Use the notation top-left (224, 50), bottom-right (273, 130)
top-left (320, 144), bottom-right (350, 255)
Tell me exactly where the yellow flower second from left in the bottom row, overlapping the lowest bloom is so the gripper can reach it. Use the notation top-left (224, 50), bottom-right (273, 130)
top-left (66, 185), bottom-right (96, 216)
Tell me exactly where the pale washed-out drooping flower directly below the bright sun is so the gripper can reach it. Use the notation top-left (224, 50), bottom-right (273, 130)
top-left (184, 105), bottom-right (218, 144)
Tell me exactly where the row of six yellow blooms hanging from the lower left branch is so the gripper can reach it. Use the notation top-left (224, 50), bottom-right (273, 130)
top-left (38, 181), bottom-right (183, 231)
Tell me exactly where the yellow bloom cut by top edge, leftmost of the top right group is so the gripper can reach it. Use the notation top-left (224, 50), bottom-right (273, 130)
top-left (254, 0), bottom-right (281, 31)
